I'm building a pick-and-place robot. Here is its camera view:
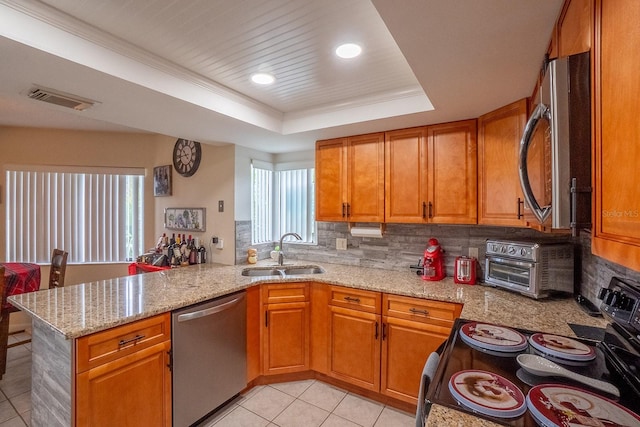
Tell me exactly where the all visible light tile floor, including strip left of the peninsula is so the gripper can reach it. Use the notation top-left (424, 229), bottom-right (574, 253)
top-left (0, 333), bottom-right (415, 427)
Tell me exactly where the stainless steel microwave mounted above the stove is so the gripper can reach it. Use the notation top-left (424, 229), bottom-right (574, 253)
top-left (518, 52), bottom-right (591, 234)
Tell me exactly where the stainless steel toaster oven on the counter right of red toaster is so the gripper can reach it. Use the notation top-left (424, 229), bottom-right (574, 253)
top-left (485, 240), bottom-right (574, 298)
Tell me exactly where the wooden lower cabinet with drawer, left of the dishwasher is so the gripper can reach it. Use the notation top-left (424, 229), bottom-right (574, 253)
top-left (75, 313), bottom-right (171, 427)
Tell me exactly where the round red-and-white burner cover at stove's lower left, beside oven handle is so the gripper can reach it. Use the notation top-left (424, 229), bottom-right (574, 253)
top-left (449, 370), bottom-right (527, 418)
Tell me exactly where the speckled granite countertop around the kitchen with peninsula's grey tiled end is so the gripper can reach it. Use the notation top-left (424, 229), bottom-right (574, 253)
top-left (10, 262), bottom-right (604, 426)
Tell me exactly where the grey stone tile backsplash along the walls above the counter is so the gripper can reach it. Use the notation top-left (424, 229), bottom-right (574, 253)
top-left (236, 221), bottom-right (640, 305)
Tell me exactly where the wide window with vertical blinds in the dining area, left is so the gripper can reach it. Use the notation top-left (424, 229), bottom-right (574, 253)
top-left (5, 166), bottom-right (144, 263)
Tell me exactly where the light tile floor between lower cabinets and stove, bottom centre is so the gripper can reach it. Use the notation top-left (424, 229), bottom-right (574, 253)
top-left (200, 380), bottom-right (415, 427)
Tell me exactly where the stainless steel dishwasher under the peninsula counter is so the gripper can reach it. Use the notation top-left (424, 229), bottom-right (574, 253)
top-left (171, 291), bottom-right (247, 427)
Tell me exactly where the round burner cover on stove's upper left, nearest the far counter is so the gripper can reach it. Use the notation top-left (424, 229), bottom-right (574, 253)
top-left (460, 322), bottom-right (528, 353)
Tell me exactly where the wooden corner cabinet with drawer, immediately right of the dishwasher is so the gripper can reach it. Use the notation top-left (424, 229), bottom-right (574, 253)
top-left (262, 283), bottom-right (310, 375)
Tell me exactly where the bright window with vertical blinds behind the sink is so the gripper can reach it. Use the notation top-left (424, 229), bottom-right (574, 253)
top-left (251, 160), bottom-right (316, 244)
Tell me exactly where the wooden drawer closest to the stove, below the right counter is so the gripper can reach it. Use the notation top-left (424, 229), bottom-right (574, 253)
top-left (382, 294), bottom-right (462, 327)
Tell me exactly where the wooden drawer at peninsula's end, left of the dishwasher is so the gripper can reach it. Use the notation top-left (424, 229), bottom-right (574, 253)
top-left (76, 313), bottom-right (171, 372)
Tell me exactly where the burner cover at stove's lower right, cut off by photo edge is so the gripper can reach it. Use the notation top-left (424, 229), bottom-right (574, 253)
top-left (527, 384), bottom-right (640, 427)
